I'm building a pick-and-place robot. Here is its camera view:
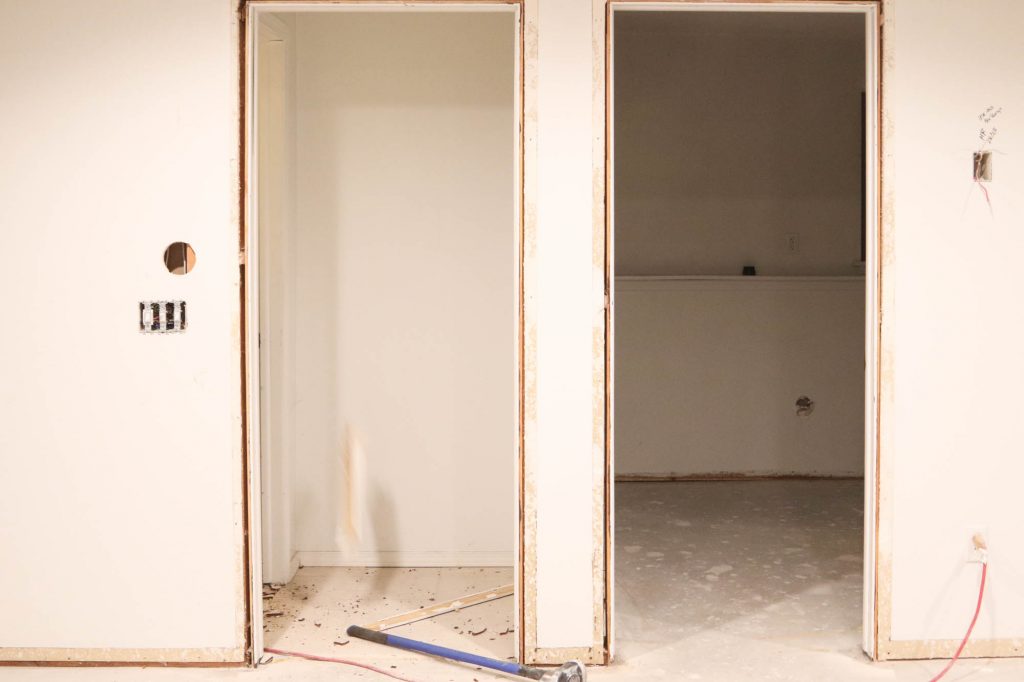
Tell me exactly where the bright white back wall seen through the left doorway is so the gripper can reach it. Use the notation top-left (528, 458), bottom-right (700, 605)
top-left (280, 11), bottom-right (517, 565)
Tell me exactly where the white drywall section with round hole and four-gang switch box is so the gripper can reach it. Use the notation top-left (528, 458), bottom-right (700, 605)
top-left (0, 0), bottom-right (245, 662)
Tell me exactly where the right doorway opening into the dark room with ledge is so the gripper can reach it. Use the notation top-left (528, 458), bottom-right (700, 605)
top-left (608, 2), bottom-right (879, 667)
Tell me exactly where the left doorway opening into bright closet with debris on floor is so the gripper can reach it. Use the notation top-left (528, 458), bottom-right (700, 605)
top-left (247, 2), bottom-right (521, 667)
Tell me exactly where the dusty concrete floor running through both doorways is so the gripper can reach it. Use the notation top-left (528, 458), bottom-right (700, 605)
top-left (0, 481), bottom-right (1024, 682)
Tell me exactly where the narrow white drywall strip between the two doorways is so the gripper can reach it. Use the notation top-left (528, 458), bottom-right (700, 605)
top-left (524, 0), bottom-right (604, 650)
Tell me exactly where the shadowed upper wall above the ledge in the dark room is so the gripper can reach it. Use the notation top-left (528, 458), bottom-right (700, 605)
top-left (614, 11), bottom-right (864, 275)
